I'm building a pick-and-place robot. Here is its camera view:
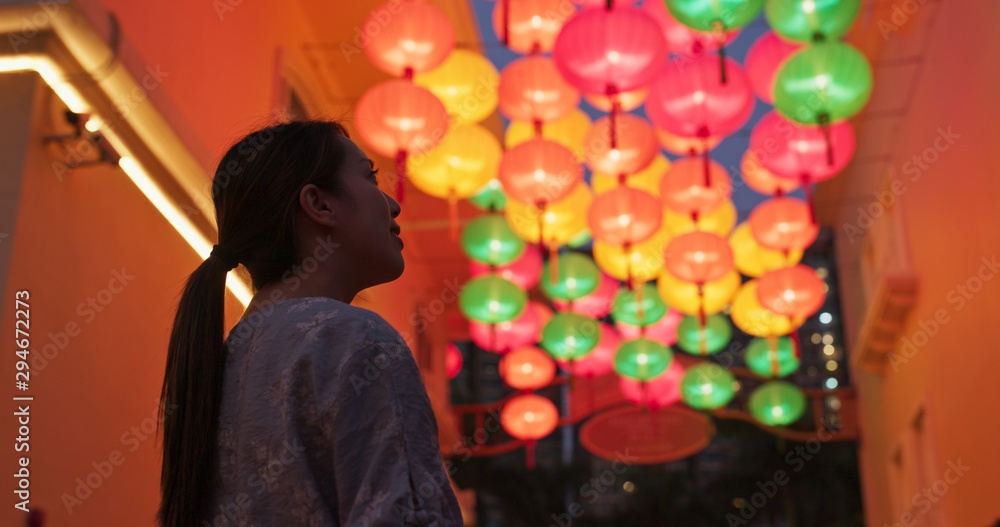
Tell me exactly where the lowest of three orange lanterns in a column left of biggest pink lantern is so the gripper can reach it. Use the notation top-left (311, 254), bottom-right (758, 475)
top-left (500, 139), bottom-right (583, 208)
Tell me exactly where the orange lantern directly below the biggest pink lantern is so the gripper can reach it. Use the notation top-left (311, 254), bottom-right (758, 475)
top-left (583, 113), bottom-right (659, 175)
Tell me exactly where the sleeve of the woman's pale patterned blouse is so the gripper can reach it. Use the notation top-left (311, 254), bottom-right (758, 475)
top-left (317, 338), bottom-right (462, 527)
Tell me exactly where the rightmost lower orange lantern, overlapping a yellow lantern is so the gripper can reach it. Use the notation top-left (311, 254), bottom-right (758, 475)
top-left (757, 265), bottom-right (826, 319)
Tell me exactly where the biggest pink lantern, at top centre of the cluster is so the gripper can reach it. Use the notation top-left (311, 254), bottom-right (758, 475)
top-left (552, 6), bottom-right (667, 95)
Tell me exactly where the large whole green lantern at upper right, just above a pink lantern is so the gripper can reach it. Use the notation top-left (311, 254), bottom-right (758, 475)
top-left (774, 42), bottom-right (872, 125)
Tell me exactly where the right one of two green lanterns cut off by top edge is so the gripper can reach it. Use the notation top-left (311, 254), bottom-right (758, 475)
top-left (764, 0), bottom-right (861, 42)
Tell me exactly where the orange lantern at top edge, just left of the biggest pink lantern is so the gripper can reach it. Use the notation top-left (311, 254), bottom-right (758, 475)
top-left (493, 0), bottom-right (573, 54)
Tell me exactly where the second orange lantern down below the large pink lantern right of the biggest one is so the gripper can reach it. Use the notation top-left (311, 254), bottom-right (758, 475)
top-left (663, 231), bottom-right (733, 284)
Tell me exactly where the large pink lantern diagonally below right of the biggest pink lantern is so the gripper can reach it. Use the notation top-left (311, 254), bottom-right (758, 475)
top-left (646, 55), bottom-right (754, 138)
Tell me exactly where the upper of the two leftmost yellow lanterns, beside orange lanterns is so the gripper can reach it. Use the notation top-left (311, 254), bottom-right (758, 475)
top-left (413, 49), bottom-right (500, 123)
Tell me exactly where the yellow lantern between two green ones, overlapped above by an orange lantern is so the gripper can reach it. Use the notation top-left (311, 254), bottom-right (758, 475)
top-left (504, 183), bottom-right (593, 249)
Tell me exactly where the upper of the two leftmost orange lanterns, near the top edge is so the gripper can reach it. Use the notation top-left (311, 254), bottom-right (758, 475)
top-left (362, 2), bottom-right (455, 77)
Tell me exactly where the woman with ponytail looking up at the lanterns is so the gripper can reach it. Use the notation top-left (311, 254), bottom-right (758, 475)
top-left (158, 121), bottom-right (462, 527)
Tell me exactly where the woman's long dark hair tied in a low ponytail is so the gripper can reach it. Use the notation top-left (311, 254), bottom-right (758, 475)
top-left (157, 121), bottom-right (347, 527)
